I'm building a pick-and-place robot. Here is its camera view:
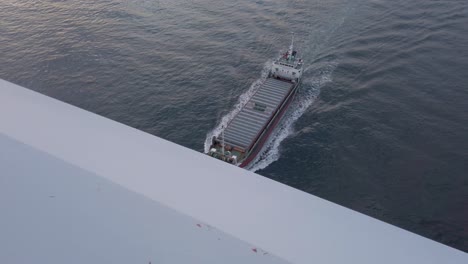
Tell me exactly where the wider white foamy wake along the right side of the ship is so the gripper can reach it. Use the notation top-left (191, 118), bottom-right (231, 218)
top-left (246, 62), bottom-right (336, 172)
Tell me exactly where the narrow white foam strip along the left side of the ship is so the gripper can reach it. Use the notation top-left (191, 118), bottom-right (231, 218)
top-left (204, 60), bottom-right (273, 153)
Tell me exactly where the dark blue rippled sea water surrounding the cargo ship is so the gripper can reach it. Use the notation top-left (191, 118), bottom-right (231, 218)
top-left (0, 0), bottom-right (468, 252)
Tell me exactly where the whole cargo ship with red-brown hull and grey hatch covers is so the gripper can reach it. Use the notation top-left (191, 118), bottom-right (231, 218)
top-left (208, 36), bottom-right (303, 167)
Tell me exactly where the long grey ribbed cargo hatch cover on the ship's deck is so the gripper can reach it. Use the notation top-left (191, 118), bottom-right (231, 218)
top-left (219, 78), bottom-right (294, 150)
